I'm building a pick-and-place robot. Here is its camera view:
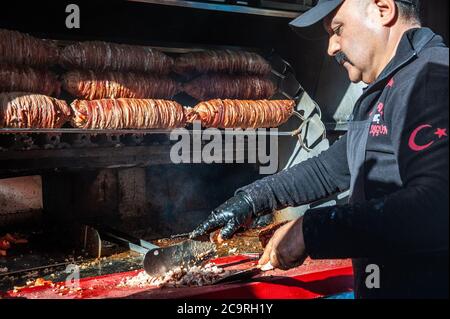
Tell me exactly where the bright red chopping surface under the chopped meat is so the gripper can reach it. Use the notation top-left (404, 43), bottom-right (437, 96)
top-left (3, 256), bottom-right (353, 299)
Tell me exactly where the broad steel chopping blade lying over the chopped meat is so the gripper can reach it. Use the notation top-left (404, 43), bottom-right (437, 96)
top-left (144, 236), bottom-right (217, 276)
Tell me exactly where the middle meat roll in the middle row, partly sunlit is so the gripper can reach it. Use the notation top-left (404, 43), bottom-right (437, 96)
top-left (63, 71), bottom-right (179, 100)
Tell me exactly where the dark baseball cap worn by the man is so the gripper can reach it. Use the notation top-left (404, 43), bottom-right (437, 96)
top-left (289, 0), bottom-right (419, 39)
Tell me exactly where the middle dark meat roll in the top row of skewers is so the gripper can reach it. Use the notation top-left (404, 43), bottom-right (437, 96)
top-left (60, 41), bottom-right (173, 74)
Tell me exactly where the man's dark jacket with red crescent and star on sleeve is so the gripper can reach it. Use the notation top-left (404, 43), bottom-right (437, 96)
top-left (238, 28), bottom-right (449, 298)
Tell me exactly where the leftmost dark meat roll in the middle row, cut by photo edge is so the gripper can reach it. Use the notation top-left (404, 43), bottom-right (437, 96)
top-left (0, 67), bottom-right (61, 97)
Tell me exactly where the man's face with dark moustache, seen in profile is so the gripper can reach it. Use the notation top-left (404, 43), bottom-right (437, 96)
top-left (324, 0), bottom-right (384, 84)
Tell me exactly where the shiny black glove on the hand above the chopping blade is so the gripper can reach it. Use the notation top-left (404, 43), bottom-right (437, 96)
top-left (189, 192), bottom-right (255, 239)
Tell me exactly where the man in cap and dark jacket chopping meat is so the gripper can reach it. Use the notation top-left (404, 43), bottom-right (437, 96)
top-left (191, 0), bottom-right (449, 298)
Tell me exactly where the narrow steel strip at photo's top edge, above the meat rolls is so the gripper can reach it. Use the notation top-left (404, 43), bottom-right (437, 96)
top-left (128, 0), bottom-right (300, 18)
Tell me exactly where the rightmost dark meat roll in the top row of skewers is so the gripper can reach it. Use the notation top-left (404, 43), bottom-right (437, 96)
top-left (174, 50), bottom-right (272, 75)
